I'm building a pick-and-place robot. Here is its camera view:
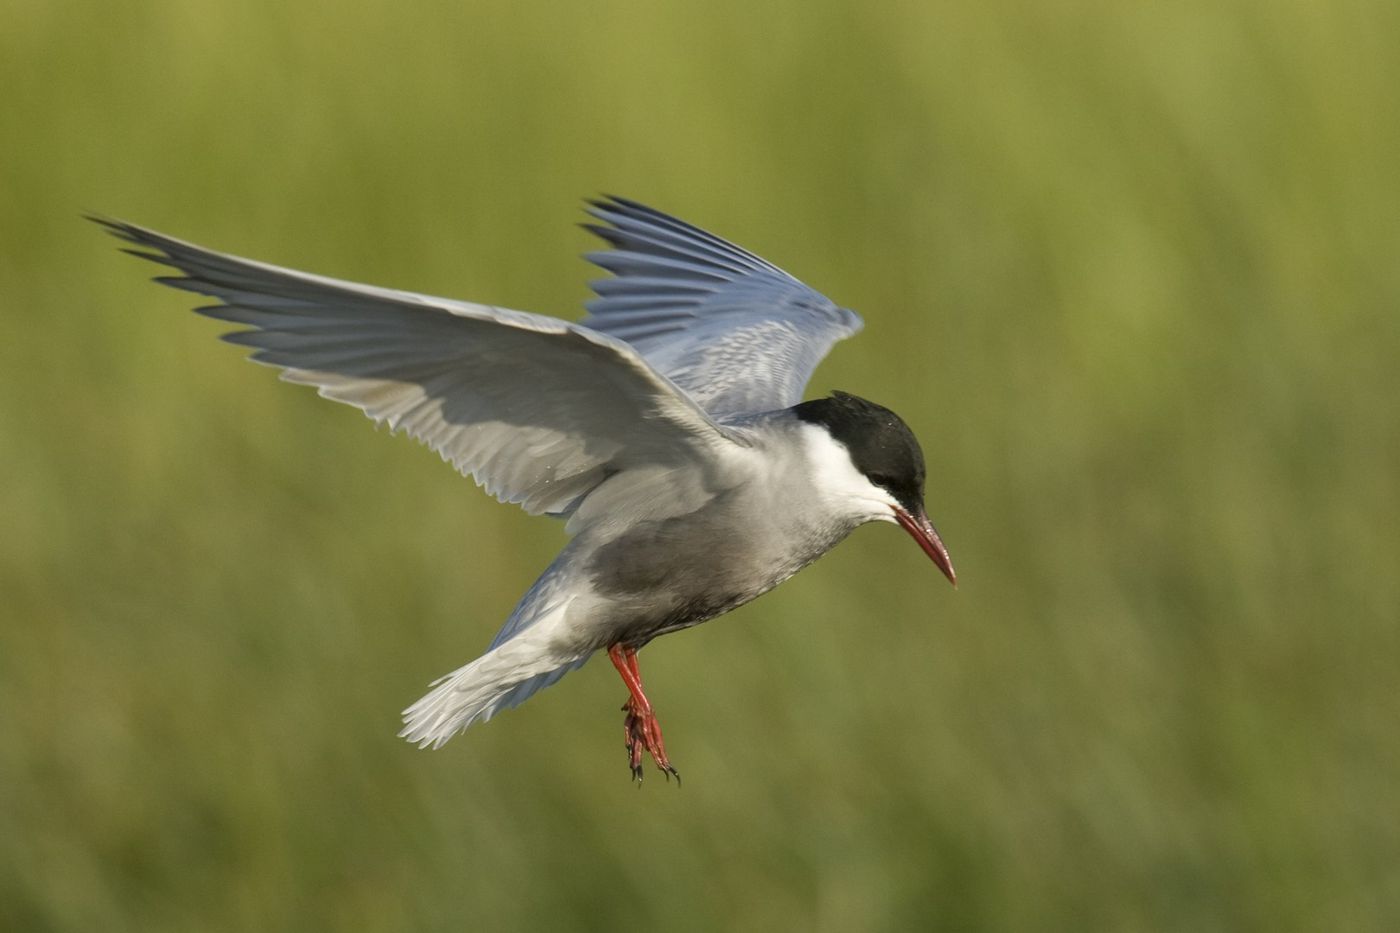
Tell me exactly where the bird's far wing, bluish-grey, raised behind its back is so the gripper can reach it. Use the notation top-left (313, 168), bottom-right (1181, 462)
top-left (582, 198), bottom-right (862, 417)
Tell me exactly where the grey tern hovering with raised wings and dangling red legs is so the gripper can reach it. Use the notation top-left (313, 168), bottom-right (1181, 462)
top-left (88, 195), bottom-right (958, 785)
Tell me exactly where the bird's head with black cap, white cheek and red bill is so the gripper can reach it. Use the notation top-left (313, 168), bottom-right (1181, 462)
top-left (792, 392), bottom-right (958, 586)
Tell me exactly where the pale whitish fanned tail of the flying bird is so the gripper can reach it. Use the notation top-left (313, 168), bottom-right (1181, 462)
top-left (399, 624), bottom-right (591, 748)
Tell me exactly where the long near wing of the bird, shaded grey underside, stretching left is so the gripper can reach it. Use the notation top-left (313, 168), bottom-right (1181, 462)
top-left (94, 217), bottom-right (742, 513)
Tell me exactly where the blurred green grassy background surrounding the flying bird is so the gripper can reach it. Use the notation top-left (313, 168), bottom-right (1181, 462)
top-left (0, 0), bottom-right (1400, 932)
